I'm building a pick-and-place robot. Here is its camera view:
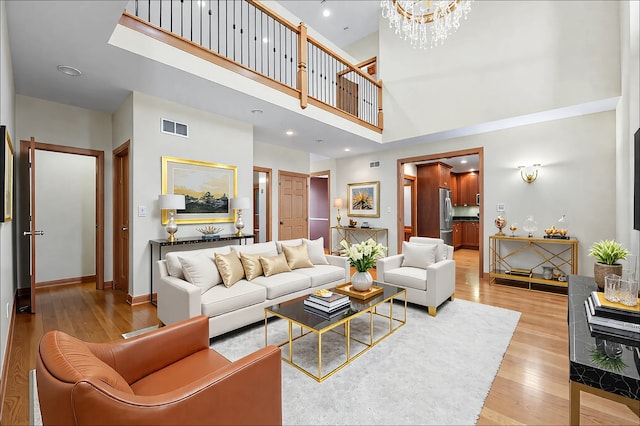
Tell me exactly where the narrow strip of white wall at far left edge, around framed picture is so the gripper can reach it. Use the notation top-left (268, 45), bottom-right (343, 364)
top-left (0, 1), bottom-right (16, 385)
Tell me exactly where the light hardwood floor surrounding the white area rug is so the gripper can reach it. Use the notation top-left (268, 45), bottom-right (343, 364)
top-left (1, 250), bottom-right (638, 425)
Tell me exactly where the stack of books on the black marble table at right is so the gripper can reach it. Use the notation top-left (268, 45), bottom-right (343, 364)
top-left (584, 291), bottom-right (640, 345)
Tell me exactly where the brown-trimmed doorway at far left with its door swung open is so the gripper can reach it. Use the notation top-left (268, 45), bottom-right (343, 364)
top-left (18, 137), bottom-right (104, 313)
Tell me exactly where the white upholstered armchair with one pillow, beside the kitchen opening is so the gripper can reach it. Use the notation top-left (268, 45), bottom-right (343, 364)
top-left (376, 237), bottom-right (456, 317)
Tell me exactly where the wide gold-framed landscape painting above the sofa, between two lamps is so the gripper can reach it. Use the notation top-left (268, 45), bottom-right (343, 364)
top-left (162, 157), bottom-right (237, 224)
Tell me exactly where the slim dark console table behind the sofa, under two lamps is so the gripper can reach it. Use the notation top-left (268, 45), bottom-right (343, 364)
top-left (149, 234), bottom-right (255, 305)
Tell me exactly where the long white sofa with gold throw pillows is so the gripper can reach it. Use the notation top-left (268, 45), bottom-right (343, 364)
top-left (155, 239), bottom-right (350, 338)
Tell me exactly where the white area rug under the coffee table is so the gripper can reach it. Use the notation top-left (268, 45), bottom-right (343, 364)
top-left (30, 300), bottom-right (520, 425)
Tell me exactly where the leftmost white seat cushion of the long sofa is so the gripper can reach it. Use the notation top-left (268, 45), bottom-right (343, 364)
top-left (200, 280), bottom-right (267, 317)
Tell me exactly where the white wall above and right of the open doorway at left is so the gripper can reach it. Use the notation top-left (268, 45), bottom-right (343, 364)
top-left (16, 95), bottom-right (113, 288)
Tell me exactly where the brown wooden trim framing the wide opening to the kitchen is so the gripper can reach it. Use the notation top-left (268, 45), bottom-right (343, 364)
top-left (397, 148), bottom-right (484, 277)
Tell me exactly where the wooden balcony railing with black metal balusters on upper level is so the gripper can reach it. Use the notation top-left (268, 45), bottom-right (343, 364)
top-left (120, 0), bottom-right (383, 133)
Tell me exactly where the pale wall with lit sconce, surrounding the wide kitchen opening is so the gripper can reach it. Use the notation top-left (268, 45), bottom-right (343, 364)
top-left (332, 111), bottom-right (616, 275)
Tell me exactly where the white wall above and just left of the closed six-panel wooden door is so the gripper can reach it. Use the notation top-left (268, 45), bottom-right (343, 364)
top-left (254, 142), bottom-right (310, 241)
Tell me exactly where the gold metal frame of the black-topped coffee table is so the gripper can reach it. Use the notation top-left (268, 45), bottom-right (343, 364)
top-left (264, 282), bottom-right (407, 382)
